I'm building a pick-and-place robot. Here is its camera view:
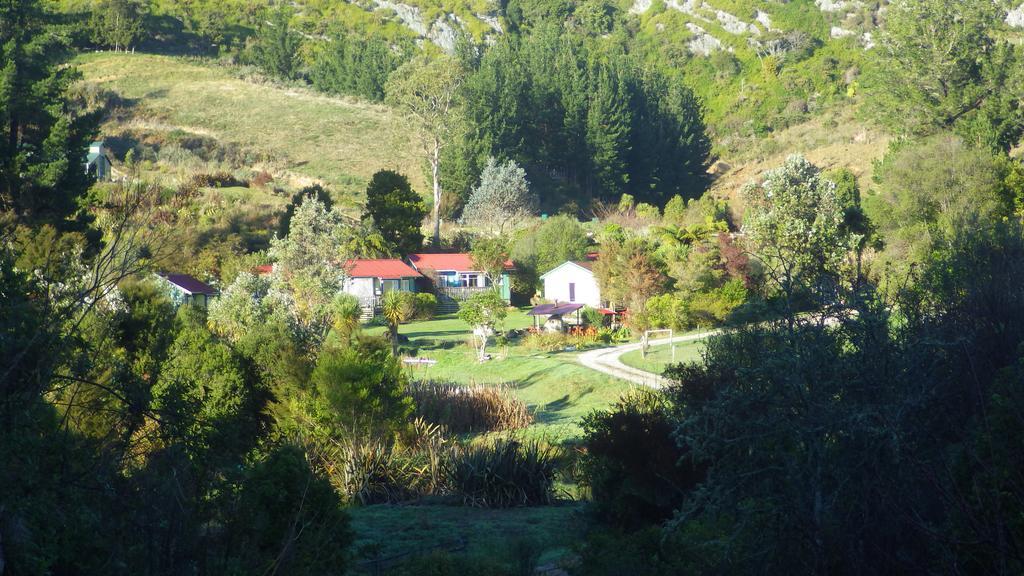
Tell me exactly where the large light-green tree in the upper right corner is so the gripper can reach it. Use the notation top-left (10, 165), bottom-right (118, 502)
top-left (873, 0), bottom-right (1021, 150)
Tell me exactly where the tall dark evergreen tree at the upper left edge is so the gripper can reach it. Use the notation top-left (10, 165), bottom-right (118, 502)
top-left (0, 0), bottom-right (95, 230)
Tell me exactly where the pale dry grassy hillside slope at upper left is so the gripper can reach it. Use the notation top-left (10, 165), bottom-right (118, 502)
top-left (76, 52), bottom-right (426, 205)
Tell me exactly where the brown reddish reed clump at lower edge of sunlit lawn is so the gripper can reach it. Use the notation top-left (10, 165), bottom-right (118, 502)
top-left (409, 380), bottom-right (534, 434)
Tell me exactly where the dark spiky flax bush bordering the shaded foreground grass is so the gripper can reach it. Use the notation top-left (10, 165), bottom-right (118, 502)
top-left (447, 439), bottom-right (556, 508)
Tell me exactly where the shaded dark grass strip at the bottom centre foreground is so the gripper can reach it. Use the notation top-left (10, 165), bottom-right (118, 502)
top-left (350, 503), bottom-right (583, 574)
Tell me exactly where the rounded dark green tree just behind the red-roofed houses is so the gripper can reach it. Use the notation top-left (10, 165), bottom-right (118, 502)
top-left (362, 170), bottom-right (427, 255)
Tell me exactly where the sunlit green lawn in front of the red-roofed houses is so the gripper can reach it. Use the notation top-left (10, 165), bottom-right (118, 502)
top-left (368, 310), bottom-right (631, 441)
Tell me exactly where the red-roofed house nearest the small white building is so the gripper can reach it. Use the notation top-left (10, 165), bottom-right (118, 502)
top-left (409, 252), bottom-right (515, 304)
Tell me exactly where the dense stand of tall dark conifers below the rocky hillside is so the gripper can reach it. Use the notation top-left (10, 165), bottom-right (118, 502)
top-left (452, 28), bottom-right (711, 207)
